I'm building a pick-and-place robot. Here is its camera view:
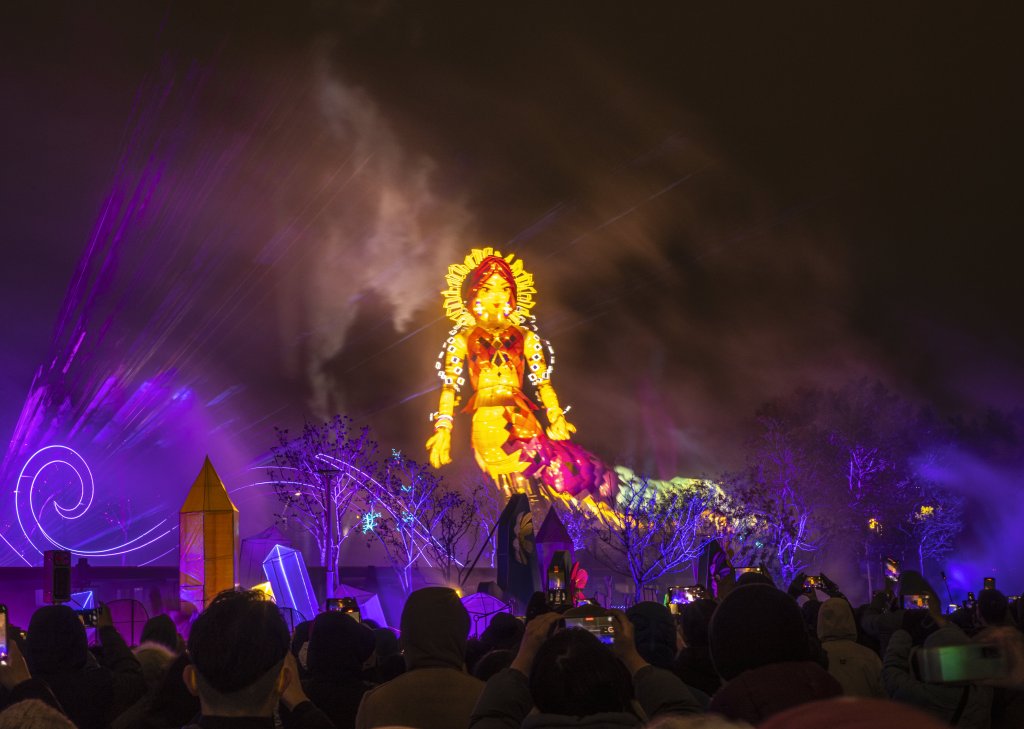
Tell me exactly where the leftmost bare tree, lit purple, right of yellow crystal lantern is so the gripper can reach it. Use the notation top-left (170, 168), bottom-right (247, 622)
top-left (267, 416), bottom-right (377, 587)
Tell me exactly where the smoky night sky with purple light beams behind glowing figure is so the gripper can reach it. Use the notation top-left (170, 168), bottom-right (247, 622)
top-left (0, 0), bottom-right (1024, 559)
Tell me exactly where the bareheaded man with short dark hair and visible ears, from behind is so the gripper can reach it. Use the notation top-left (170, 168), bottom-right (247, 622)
top-left (183, 591), bottom-right (333, 729)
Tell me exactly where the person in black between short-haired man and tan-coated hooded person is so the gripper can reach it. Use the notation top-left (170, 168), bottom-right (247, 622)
top-left (286, 612), bottom-right (376, 729)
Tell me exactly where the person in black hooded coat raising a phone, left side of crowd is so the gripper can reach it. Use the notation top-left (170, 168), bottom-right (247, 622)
top-left (25, 605), bottom-right (145, 729)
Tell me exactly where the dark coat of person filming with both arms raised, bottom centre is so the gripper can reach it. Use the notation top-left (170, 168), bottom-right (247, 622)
top-left (469, 666), bottom-right (699, 729)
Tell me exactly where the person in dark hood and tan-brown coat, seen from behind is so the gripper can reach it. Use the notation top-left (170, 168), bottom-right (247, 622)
top-left (355, 587), bottom-right (483, 729)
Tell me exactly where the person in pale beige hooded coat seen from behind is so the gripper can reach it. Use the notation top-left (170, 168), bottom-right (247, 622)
top-left (818, 597), bottom-right (886, 698)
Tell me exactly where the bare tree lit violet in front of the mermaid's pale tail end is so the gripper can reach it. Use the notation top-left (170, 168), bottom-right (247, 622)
top-left (590, 475), bottom-right (711, 601)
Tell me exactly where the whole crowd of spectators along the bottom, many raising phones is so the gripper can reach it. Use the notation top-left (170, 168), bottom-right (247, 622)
top-left (0, 572), bottom-right (1024, 729)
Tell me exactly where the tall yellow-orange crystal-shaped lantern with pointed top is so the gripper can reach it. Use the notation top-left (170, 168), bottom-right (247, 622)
top-left (178, 457), bottom-right (239, 610)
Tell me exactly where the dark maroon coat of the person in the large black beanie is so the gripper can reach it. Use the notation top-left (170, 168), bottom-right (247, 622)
top-left (708, 660), bottom-right (843, 725)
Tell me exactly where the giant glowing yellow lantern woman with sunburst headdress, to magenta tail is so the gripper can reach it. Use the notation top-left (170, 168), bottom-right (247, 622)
top-left (427, 248), bottom-right (615, 501)
